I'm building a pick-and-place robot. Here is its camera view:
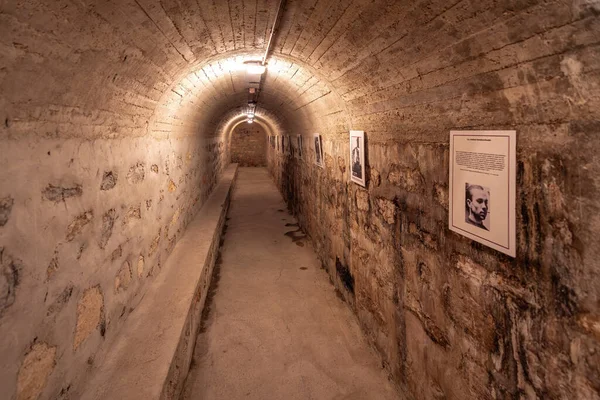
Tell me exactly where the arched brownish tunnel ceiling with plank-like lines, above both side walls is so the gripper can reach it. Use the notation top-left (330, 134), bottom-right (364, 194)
top-left (0, 0), bottom-right (598, 143)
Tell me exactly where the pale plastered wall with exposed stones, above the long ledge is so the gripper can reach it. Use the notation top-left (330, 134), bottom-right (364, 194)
top-left (0, 137), bottom-right (225, 399)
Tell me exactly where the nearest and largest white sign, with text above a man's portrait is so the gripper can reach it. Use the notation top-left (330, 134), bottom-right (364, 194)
top-left (449, 131), bottom-right (517, 257)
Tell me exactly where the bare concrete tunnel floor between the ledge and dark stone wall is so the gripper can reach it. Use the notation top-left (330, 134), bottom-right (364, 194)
top-left (182, 168), bottom-right (401, 400)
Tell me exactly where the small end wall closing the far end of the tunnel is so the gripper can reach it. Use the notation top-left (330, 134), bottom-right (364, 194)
top-left (231, 123), bottom-right (267, 167)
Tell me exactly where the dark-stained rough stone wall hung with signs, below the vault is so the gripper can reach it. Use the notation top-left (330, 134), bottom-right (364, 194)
top-left (269, 130), bottom-right (600, 400)
